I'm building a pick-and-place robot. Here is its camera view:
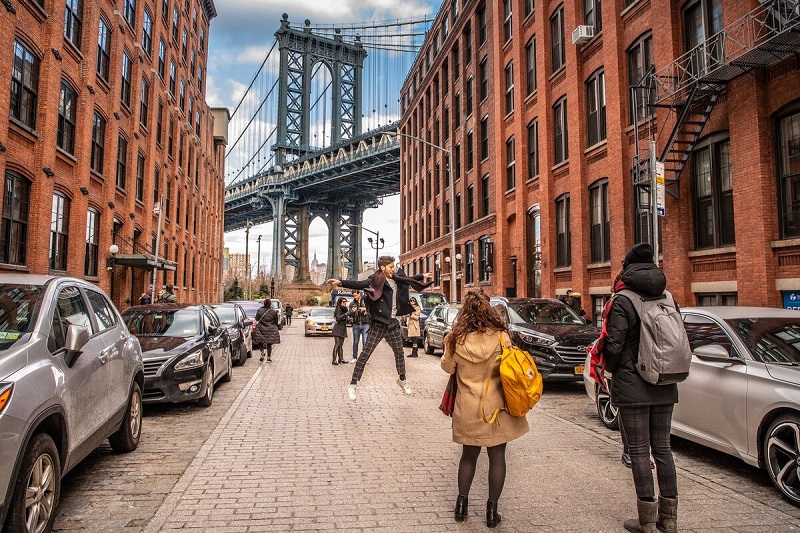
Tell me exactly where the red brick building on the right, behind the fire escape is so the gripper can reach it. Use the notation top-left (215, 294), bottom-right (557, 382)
top-left (399, 0), bottom-right (800, 322)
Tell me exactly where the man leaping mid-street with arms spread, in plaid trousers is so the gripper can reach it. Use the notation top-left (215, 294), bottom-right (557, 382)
top-left (326, 255), bottom-right (433, 401)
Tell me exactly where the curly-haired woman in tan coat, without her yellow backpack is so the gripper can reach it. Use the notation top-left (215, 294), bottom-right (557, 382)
top-left (441, 291), bottom-right (529, 527)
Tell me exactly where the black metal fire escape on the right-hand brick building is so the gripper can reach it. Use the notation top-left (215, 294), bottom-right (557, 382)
top-left (631, 0), bottom-right (800, 232)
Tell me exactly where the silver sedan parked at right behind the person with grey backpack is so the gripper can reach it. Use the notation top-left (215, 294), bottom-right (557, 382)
top-left (583, 306), bottom-right (800, 506)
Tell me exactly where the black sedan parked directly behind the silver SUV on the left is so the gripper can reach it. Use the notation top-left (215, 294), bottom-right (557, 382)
top-left (122, 304), bottom-right (233, 407)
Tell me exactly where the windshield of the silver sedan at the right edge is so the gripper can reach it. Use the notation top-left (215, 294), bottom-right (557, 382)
top-left (726, 318), bottom-right (800, 364)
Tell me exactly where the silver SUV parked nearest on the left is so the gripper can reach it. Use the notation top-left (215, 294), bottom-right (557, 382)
top-left (0, 274), bottom-right (144, 532)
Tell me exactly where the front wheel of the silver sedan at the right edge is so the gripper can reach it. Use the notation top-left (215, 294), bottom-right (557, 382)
top-left (764, 415), bottom-right (800, 505)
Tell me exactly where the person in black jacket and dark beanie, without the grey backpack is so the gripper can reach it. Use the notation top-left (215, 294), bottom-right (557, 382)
top-left (603, 243), bottom-right (678, 533)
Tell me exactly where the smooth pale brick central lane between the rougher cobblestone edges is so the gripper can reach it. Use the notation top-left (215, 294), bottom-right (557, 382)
top-left (144, 320), bottom-right (800, 533)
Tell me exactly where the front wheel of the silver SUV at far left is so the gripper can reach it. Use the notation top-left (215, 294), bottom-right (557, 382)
top-left (7, 433), bottom-right (61, 533)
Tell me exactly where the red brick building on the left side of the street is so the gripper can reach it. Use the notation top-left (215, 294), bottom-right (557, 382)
top-left (0, 0), bottom-right (228, 308)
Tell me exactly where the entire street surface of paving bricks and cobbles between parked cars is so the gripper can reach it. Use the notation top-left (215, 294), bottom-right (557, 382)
top-left (55, 320), bottom-right (800, 533)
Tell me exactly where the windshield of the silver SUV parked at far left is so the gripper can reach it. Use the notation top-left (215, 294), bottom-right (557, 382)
top-left (0, 283), bottom-right (44, 351)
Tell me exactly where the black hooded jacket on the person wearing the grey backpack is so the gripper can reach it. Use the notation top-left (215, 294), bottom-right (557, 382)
top-left (603, 263), bottom-right (678, 407)
